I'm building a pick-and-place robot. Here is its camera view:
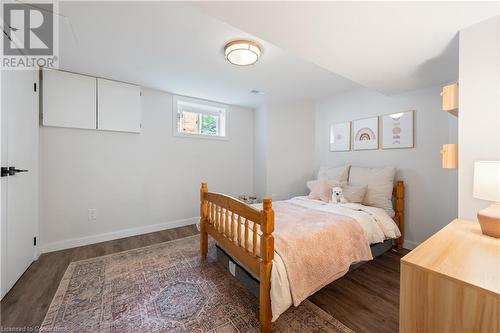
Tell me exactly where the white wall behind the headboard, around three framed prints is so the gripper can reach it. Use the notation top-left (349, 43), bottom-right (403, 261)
top-left (315, 86), bottom-right (457, 248)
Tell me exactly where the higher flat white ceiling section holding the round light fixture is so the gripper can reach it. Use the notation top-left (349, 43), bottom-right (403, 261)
top-left (59, 2), bottom-right (357, 107)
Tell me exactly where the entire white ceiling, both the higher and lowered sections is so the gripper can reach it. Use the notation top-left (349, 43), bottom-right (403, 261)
top-left (59, 1), bottom-right (500, 107)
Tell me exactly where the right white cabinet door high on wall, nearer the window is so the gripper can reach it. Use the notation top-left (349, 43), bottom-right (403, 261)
top-left (97, 78), bottom-right (141, 133)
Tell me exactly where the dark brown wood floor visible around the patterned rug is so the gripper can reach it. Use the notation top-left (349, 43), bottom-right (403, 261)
top-left (0, 226), bottom-right (408, 332)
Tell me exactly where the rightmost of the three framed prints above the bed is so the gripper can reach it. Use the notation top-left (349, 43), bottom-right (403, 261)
top-left (381, 110), bottom-right (415, 149)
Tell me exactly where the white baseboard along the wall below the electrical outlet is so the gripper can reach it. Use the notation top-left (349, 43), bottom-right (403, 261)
top-left (40, 217), bottom-right (200, 253)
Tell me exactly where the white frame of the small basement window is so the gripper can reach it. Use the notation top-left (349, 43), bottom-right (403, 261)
top-left (172, 95), bottom-right (229, 141)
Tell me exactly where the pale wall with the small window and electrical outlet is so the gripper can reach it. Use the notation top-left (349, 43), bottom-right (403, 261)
top-left (40, 89), bottom-right (254, 251)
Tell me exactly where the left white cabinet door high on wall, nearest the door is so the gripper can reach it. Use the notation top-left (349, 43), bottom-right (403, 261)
top-left (42, 69), bottom-right (97, 129)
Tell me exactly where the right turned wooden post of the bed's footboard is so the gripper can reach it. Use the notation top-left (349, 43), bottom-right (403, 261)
top-left (259, 198), bottom-right (274, 333)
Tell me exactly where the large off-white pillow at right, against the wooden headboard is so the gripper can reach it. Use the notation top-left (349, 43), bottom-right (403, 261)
top-left (349, 167), bottom-right (396, 217)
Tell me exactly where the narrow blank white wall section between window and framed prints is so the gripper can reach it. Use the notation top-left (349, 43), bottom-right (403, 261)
top-left (254, 102), bottom-right (314, 200)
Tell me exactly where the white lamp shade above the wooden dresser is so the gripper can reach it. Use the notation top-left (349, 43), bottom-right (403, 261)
top-left (473, 161), bottom-right (500, 202)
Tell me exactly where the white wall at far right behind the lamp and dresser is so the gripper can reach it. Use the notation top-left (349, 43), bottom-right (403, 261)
top-left (458, 16), bottom-right (500, 220)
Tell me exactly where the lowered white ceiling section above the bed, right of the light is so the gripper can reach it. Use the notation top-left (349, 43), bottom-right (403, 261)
top-left (196, 1), bottom-right (500, 94)
